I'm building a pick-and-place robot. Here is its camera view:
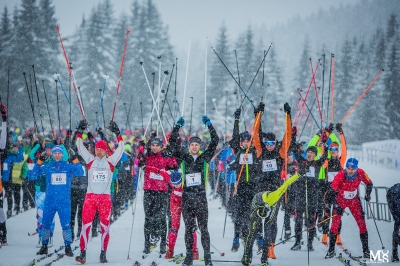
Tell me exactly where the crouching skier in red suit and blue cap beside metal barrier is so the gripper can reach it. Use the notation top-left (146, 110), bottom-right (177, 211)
top-left (325, 158), bottom-right (373, 259)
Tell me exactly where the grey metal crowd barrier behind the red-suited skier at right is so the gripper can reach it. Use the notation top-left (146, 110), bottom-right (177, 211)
top-left (358, 184), bottom-right (392, 223)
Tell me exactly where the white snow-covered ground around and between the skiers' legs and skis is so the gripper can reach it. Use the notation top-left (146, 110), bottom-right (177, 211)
top-left (0, 158), bottom-right (400, 266)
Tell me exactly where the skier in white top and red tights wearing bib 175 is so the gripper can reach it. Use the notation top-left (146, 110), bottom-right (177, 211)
top-left (76, 121), bottom-right (124, 264)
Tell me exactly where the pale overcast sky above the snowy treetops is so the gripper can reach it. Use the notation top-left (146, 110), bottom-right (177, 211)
top-left (0, 0), bottom-right (360, 50)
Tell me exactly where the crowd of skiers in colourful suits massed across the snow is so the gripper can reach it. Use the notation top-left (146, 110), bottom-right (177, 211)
top-left (0, 102), bottom-right (400, 266)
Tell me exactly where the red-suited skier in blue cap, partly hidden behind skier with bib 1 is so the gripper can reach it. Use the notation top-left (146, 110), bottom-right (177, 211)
top-left (165, 171), bottom-right (199, 260)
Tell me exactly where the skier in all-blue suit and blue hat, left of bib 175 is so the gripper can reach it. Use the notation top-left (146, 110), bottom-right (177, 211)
top-left (33, 146), bottom-right (83, 257)
